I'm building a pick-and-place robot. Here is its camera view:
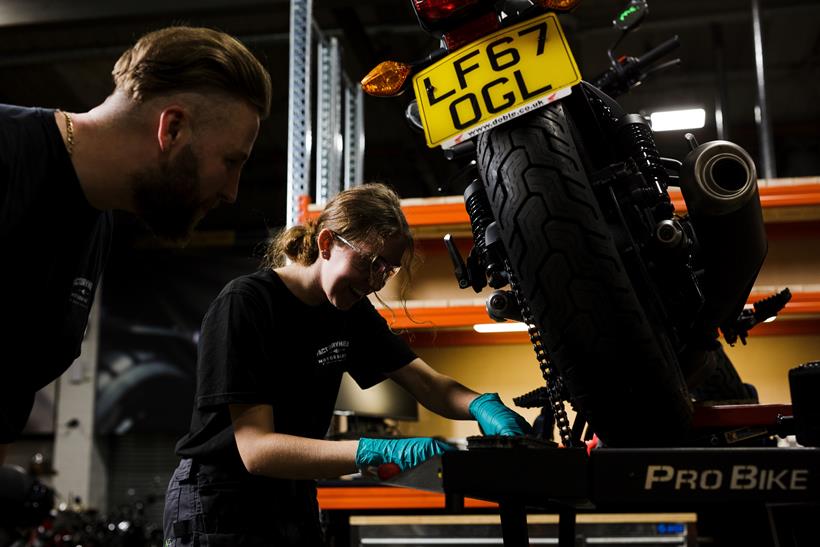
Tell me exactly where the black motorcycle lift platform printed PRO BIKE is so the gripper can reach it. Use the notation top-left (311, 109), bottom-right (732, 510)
top-left (383, 405), bottom-right (820, 547)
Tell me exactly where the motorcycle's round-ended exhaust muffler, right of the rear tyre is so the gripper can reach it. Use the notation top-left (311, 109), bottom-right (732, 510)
top-left (680, 141), bottom-right (768, 327)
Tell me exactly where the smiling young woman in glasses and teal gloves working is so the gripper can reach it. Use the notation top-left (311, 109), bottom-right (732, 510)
top-left (165, 184), bottom-right (529, 546)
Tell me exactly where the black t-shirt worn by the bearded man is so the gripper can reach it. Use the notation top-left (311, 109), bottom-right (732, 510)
top-left (0, 105), bottom-right (112, 443)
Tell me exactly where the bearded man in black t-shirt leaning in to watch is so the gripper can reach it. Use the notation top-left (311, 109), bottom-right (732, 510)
top-left (0, 26), bottom-right (271, 463)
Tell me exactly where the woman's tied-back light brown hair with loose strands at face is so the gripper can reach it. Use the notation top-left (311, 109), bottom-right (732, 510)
top-left (263, 183), bottom-right (415, 295)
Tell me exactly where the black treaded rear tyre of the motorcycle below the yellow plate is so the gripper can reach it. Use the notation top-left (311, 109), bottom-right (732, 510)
top-left (477, 102), bottom-right (692, 446)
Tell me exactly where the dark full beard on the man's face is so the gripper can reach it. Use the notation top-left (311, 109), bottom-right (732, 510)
top-left (132, 144), bottom-right (204, 244)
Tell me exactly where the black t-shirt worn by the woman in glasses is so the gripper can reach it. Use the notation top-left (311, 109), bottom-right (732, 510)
top-left (177, 270), bottom-right (416, 468)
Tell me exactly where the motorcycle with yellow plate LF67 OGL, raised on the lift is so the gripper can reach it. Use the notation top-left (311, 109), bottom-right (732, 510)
top-left (362, 0), bottom-right (789, 446)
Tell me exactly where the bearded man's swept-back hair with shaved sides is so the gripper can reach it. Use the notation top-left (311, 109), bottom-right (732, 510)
top-left (111, 26), bottom-right (271, 118)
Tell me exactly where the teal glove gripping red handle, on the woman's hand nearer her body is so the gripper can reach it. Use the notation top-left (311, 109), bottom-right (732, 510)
top-left (356, 437), bottom-right (456, 471)
